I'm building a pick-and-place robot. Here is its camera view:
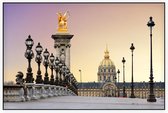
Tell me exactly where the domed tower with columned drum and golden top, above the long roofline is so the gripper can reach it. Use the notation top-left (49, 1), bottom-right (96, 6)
top-left (97, 48), bottom-right (116, 83)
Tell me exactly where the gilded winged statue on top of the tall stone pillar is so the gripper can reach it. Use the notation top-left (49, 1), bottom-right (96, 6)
top-left (57, 11), bottom-right (69, 32)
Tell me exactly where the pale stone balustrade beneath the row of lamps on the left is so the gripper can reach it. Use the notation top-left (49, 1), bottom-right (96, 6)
top-left (3, 83), bottom-right (76, 102)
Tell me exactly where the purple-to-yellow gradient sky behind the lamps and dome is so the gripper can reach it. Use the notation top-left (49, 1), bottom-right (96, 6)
top-left (3, 3), bottom-right (165, 82)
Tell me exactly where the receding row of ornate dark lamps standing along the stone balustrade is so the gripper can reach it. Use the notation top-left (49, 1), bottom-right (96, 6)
top-left (25, 35), bottom-right (78, 94)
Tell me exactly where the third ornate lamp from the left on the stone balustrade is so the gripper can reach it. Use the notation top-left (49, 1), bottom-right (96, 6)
top-left (43, 49), bottom-right (50, 84)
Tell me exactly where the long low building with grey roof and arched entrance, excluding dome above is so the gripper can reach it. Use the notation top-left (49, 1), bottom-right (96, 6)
top-left (78, 82), bottom-right (165, 98)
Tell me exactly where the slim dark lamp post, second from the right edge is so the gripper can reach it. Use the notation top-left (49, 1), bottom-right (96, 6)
top-left (130, 43), bottom-right (135, 98)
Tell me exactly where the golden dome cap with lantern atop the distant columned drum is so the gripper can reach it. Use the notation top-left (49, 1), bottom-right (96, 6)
top-left (100, 47), bottom-right (114, 67)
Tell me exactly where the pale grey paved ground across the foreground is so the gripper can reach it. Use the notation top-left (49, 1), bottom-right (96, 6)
top-left (4, 96), bottom-right (164, 109)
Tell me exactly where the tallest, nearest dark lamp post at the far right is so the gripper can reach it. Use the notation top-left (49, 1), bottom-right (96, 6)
top-left (147, 17), bottom-right (156, 102)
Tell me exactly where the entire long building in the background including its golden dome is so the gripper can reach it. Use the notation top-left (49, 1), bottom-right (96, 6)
top-left (78, 48), bottom-right (165, 98)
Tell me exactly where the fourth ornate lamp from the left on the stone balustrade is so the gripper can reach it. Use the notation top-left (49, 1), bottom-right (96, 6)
top-left (49, 53), bottom-right (54, 85)
